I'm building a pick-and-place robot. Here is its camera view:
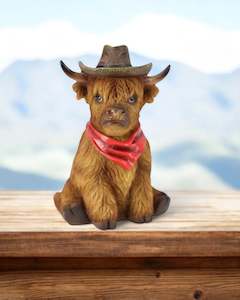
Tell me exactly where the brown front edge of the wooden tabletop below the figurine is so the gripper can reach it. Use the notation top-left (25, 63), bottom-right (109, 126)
top-left (0, 231), bottom-right (240, 258)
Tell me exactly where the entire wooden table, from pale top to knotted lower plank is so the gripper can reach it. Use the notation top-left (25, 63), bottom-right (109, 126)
top-left (0, 191), bottom-right (240, 300)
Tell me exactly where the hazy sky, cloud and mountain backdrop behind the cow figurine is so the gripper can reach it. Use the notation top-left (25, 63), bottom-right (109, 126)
top-left (0, 0), bottom-right (240, 190)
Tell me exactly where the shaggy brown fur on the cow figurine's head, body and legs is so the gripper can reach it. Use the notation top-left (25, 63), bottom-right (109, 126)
top-left (54, 77), bottom-right (170, 229)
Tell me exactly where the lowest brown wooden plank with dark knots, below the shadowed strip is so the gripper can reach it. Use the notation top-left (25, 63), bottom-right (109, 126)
top-left (0, 269), bottom-right (240, 300)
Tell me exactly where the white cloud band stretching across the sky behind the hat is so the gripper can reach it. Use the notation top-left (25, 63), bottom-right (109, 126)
top-left (0, 14), bottom-right (240, 72)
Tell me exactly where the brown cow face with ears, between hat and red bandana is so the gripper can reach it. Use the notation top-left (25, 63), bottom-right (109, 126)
top-left (73, 77), bottom-right (158, 137)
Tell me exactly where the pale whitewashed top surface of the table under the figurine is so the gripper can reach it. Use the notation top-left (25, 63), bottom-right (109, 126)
top-left (0, 191), bottom-right (240, 232)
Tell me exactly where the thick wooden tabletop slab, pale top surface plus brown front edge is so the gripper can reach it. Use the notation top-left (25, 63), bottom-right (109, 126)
top-left (0, 191), bottom-right (240, 257)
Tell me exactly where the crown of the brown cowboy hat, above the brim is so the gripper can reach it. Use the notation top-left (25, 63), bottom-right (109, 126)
top-left (97, 45), bottom-right (132, 68)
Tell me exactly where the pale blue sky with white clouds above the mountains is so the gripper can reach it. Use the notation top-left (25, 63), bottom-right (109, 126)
top-left (0, 0), bottom-right (240, 73)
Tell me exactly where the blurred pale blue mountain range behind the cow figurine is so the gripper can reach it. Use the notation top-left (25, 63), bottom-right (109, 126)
top-left (0, 53), bottom-right (240, 190)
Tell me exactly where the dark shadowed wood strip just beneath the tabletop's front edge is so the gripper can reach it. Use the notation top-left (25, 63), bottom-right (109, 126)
top-left (0, 257), bottom-right (240, 270)
